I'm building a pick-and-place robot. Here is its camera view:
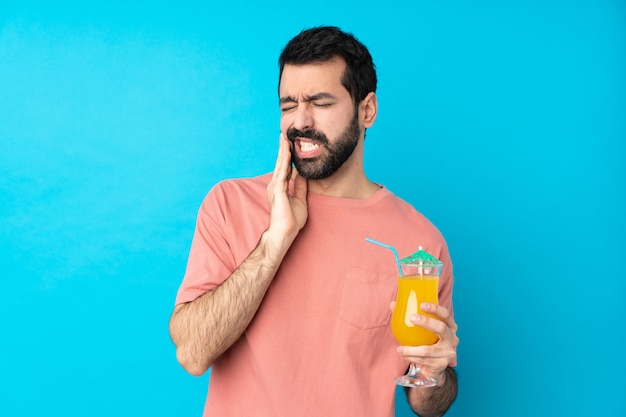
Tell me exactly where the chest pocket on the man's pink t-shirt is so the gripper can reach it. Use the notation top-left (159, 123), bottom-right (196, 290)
top-left (339, 266), bottom-right (397, 329)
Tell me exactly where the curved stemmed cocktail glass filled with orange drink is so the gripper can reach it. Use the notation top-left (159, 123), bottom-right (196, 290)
top-left (391, 261), bottom-right (443, 387)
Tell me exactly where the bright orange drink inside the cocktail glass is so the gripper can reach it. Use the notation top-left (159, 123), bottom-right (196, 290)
top-left (391, 275), bottom-right (439, 346)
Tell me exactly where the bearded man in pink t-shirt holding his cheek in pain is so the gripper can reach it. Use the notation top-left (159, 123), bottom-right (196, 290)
top-left (170, 27), bottom-right (458, 417)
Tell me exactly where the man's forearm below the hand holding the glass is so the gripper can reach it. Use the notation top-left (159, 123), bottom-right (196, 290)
top-left (406, 367), bottom-right (458, 417)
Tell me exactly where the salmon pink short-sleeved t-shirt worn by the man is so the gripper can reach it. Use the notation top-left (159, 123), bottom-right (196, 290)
top-left (176, 174), bottom-right (453, 417)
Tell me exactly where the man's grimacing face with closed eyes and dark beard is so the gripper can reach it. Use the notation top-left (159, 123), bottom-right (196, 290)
top-left (279, 59), bottom-right (362, 179)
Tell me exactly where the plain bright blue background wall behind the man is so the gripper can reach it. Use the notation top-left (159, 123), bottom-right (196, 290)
top-left (0, 0), bottom-right (626, 416)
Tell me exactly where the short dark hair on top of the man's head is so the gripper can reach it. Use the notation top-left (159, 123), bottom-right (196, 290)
top-left (278, 26), bottom-right (376, 106)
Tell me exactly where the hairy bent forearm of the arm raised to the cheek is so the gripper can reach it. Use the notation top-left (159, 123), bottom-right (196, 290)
top-left (170, 232), bottom-right (284, 375)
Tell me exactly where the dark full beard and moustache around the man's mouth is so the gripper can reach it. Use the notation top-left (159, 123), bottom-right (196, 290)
top-left (287, 111), bottom-right (361, 180)
